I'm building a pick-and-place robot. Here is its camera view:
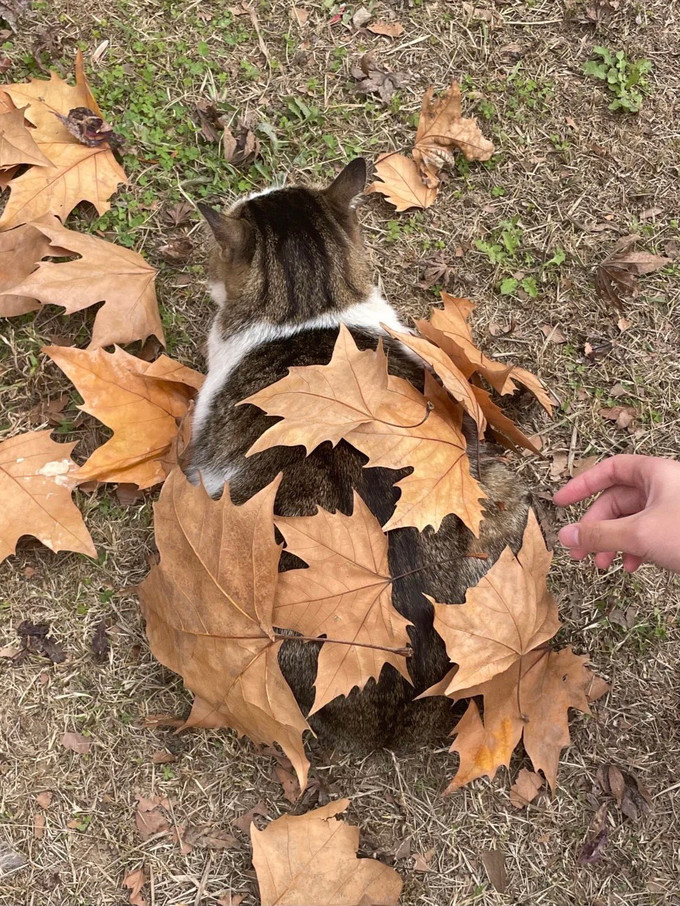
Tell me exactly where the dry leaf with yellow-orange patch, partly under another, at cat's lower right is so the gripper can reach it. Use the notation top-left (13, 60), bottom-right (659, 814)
top-left (446, 648), bottom-right (592, 793)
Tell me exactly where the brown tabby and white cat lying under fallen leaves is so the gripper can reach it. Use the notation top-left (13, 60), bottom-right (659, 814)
top-left (186, 158), bottom-right (528, 751)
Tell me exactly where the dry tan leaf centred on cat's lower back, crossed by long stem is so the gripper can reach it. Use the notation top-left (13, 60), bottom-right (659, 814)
top-left (273, 492), bottom-right (410, 714)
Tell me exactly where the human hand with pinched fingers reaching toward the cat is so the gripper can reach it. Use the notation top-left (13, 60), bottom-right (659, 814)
top-left (553, 455), bottom-right (680, 573)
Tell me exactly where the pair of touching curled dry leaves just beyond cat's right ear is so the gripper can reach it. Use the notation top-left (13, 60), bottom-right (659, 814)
top-left (366, 81), bottom-right (494, 211)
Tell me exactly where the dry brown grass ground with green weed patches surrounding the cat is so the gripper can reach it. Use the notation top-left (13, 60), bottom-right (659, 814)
top-left (0, 0), bottom-right (680, 906)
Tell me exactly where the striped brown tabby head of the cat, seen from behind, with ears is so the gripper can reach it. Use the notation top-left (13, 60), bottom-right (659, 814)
top-left (199, 158), bottom-right (372, 331)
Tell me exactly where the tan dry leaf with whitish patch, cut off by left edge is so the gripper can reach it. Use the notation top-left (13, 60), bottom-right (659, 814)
top-left (0, 429), bottom-right (97, 562)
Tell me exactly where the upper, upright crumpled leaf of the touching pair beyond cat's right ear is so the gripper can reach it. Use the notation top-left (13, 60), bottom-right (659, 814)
top-left (413, 81), bottom-right (494, 189)
